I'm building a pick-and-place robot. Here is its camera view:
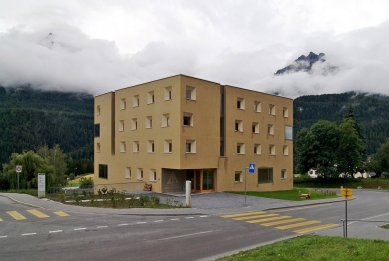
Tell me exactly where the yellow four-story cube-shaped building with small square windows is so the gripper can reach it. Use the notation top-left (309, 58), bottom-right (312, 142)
top-left (94, 75), bottom-right (293, 193)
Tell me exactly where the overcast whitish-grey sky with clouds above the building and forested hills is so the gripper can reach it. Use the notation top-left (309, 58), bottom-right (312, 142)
top-left (0, 0), bottom-right (389, 98)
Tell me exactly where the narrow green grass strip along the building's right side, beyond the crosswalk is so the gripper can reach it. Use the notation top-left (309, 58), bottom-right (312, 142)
top-left (230, 188), bottom-right (339, 201)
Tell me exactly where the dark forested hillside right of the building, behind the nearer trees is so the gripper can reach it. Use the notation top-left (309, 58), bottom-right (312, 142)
top-left (293, 92), bottom-right (389, 155)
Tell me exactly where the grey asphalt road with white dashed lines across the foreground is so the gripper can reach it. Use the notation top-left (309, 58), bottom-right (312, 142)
top-left (0, 191), bottom-right (389, 261)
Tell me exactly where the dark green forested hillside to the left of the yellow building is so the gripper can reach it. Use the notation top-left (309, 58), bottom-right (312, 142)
top-left (0, 86), bottom-right (93, 172)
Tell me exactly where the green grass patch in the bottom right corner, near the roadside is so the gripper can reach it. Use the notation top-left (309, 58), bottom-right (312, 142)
top-left (217, 235), bottom-right (389, 261)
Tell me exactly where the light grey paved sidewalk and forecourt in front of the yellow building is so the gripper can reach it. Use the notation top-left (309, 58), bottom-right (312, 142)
top-left (0, 192), bottom-right (344, 216)
